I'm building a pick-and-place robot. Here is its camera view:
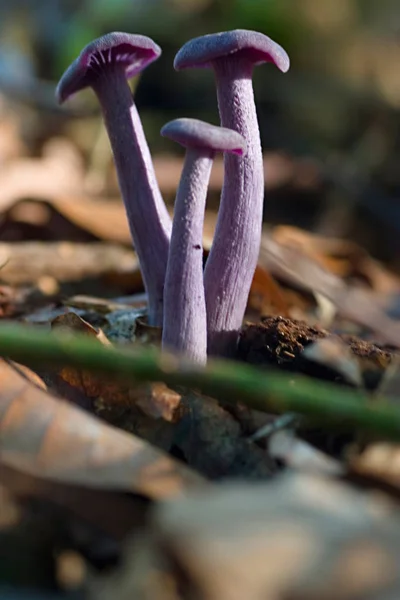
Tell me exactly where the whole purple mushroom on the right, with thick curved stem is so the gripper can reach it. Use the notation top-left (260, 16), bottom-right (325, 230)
top-left (174, 29), bottom-right (289, 354)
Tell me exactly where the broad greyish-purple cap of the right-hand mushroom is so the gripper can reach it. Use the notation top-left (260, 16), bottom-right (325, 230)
top-left (174, 29), bottom-right (290, 73)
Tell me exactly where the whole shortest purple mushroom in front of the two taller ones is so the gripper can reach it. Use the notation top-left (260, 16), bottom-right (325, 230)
top-left (161, 119), bottom-right (246, 364)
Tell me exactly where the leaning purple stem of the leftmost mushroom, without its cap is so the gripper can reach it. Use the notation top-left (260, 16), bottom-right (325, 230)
top-left (92, 65), bottom-right (171, 326)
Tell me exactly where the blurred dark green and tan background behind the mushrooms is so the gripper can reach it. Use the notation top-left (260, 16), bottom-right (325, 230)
top-left (0, 0), bottom-right (400, 262)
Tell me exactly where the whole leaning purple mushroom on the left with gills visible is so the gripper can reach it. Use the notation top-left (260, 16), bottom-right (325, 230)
top-left (56, 32), bottom-right (172, 326)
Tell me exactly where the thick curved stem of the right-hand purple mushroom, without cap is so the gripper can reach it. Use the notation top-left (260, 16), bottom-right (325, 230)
top-left (204, 57), bottom-right (264, 354)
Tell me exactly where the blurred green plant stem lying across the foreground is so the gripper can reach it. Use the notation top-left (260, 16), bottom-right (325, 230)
top-left (0, 324), bottom-right (400, 440)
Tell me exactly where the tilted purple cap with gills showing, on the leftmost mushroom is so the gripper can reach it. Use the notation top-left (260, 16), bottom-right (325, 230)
top-left (56, 31), bottom-right (161, 104)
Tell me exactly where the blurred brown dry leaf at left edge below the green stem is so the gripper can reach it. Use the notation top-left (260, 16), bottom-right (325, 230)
top-left (0, 362), bottom-right (202, 499)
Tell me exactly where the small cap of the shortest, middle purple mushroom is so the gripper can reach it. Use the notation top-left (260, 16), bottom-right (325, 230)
top-left (161, 119), bottom-right (246, 156)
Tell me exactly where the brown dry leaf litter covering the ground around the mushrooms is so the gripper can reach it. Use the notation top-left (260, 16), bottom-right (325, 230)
top-left (0, 48), bottom-right (400, 600)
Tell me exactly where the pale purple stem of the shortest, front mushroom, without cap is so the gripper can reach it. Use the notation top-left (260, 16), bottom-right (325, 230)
top-left (162, 148), bottom-right (211, 364)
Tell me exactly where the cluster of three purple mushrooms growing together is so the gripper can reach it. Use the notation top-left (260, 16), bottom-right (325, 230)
top-left (56, 30), bottom-right (289, 364)
